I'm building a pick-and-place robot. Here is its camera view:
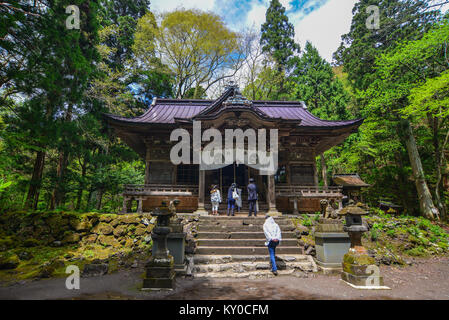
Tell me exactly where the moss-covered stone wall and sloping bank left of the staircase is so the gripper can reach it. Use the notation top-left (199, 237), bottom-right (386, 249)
top-left (0, 211), bottom-right (155, 281)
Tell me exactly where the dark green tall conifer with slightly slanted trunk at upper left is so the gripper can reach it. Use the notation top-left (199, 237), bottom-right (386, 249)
top-left (1, 0), bottom-right (98, 208)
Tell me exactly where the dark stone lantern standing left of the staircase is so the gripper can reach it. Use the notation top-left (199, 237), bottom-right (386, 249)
top-left (142, 204), bottom-right (175, 290)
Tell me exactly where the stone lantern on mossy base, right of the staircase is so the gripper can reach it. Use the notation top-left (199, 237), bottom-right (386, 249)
top-left (340, 203), bottom-right (389, 289)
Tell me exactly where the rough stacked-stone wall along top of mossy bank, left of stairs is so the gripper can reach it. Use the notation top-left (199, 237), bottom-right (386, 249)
top-left (0, 212), bottom-right (155, 251)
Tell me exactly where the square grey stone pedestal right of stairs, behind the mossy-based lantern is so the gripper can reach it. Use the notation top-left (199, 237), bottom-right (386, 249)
top-left (314, 218), bottom-right (351, 273)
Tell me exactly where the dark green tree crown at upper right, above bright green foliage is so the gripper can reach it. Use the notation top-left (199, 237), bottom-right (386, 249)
top-left (334, 0), bottom-right (439, 90)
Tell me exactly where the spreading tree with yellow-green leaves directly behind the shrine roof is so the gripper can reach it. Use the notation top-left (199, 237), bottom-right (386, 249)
top-left (134, 9), bottom-right (244, 98)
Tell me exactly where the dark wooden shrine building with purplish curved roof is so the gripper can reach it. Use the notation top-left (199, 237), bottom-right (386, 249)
top-left (105, 85), bottom-right (363, 214)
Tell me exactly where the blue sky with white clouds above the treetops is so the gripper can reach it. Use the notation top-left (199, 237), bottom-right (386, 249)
top-left (151, 0), bottom-right (447, 62)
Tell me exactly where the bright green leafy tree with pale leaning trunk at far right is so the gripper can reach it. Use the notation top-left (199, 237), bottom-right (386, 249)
top-left (367, 21), bottom-right (449, 219)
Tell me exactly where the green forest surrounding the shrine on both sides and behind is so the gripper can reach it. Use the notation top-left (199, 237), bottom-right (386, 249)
top-left (0, 0), bottom-right (449, 219)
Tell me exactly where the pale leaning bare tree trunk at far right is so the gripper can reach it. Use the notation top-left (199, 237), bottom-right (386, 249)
top-left (401, 120), bottom-right (439, 220)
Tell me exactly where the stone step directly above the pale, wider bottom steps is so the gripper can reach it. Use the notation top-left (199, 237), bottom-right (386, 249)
top-left (195, 245), bottom-right (302, 255)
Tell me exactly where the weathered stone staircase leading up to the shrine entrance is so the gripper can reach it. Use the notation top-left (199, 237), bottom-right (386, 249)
top-left (193, 216), bottom-right (317, 279)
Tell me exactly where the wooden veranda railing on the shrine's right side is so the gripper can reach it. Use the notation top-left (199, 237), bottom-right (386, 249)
top-left (275, 185), bottom-right (343, 198)
